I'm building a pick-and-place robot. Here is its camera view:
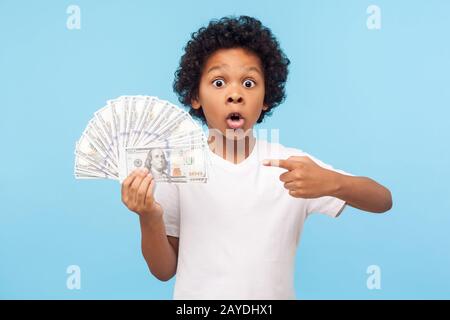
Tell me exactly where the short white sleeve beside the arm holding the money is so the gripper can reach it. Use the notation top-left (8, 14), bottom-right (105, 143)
top-left (154, 182), bottom-right (180, 238)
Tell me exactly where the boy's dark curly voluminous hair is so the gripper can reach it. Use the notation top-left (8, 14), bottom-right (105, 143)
top-left (173, 16), bottom-right (290, 123)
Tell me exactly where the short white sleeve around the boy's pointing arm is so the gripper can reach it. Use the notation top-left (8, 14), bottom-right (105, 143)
top-left (306, 154), bottom-right (353, 218)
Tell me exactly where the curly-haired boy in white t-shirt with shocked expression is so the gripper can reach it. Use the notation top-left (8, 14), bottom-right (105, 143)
top-left (122, 16), bottom-right (392, 299)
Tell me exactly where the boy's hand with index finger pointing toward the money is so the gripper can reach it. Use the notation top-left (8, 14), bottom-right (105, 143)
top-left (263, 156), bottom-right (339, 198)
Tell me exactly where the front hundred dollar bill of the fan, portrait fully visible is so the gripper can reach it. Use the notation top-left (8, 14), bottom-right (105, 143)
top-left (119, 145), bottom-right (208, 183)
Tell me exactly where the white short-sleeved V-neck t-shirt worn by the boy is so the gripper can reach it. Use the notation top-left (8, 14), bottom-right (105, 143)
top-left (155, 140), bottom-right (354, 299)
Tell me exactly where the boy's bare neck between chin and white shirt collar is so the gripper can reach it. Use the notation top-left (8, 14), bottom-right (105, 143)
top-left (208, 130), bottom-right (256, 164)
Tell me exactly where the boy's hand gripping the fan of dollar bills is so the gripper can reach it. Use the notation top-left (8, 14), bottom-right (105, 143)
top-left (122, 169), bottom-right (162, 218)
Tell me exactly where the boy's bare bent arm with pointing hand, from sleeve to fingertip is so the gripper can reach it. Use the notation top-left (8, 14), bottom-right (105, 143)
top-left (263, 156), bottom-right (392, 213)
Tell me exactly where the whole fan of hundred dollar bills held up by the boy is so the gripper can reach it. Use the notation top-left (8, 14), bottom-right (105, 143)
top-left (74, 96), bottom-right (207, 183)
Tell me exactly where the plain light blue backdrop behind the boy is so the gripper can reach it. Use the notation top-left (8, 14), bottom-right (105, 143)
top-left (0, 0), bottom-right (450, 299)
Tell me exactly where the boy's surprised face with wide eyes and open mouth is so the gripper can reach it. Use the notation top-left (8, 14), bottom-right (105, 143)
top-left (192, 48), bottom-right (267, 139)
